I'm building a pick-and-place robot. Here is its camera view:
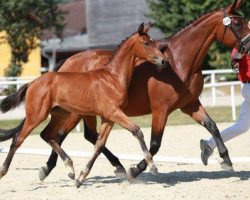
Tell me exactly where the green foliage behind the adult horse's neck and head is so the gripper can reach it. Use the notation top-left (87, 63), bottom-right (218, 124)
top-left (147, 0), bottom-right (250, 73)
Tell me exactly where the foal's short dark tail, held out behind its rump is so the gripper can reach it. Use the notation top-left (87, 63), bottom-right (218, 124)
top-left (0, 83), bottom-right (29, 113)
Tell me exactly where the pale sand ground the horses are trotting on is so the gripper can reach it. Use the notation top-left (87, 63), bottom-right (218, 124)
top-left (0, 123), bottom-right (250, 200)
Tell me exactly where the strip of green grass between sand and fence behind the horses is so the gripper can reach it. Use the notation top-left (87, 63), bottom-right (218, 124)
top-left (0, 107), bottom-right (240, 134)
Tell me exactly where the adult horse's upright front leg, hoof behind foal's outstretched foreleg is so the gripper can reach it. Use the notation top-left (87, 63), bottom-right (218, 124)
top-left (128, 110), bottom-right (168, 178)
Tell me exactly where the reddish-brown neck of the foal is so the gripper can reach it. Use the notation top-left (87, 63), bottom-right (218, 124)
top-left (106, 41), bottom-right (135, 89)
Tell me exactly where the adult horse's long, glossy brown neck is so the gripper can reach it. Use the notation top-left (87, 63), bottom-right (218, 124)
top-left (168, 14), bottom-right (221, 82)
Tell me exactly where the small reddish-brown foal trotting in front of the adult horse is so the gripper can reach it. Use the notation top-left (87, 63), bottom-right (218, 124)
top-left (0, 24), bottom-right (167, 187)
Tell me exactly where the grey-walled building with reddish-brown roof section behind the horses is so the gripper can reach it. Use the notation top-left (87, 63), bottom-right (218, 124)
top-left (42, 0), bottom-right (163, 71)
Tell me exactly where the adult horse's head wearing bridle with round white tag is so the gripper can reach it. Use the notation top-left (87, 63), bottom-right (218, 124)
top-left (216, 0), bottom-right (250, 54)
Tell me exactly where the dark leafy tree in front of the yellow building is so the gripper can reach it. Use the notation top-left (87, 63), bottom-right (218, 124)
top-left (0, 0), bottom-right (65, 76)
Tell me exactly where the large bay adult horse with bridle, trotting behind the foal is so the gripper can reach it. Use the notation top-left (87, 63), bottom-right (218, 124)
top-left (0, 0), bottom-right (250, 180)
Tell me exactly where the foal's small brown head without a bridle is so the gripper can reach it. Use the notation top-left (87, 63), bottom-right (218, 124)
top-left (133, 23), bottom-right (168, 70)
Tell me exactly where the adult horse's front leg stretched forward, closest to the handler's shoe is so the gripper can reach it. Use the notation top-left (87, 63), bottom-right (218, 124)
top-left (181, 100), bottom-right (233, 171)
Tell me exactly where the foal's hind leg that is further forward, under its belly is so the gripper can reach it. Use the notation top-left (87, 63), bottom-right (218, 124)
top-left (39, 112), bottom-right (75, 179)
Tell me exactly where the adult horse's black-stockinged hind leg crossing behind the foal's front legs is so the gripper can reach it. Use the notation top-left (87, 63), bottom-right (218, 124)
top-left (84, 116), bottom-right (127, 178)
